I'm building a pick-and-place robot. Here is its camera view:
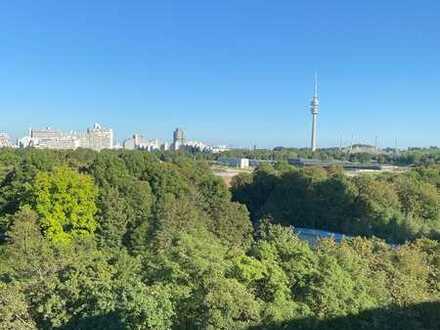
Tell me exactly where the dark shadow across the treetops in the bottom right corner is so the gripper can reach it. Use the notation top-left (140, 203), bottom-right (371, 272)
top-left (249, 302), bottom-right (440, 330)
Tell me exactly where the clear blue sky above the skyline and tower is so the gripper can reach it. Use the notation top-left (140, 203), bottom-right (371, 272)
top-left (0, 0), bottom-right (440, 147)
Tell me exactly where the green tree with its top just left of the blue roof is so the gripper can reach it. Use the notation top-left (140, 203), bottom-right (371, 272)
top-left (251, 222), bottom-right (316, 324)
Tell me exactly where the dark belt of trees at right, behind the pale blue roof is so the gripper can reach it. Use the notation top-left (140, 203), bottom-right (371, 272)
top-left (232, 163), bottom-right (440, 243)
